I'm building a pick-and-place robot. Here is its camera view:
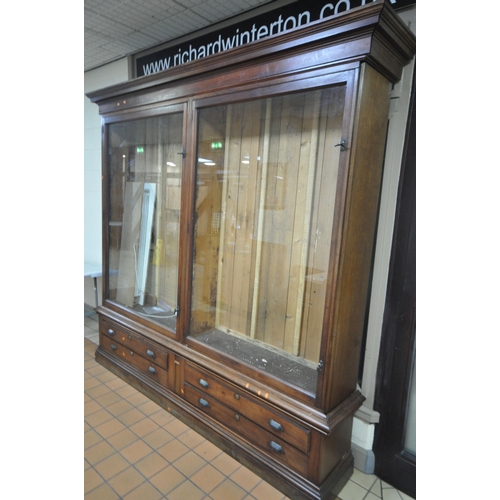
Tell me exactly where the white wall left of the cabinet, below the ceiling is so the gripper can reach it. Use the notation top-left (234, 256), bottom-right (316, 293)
top-left (84, 58), bottom-right (128, 305)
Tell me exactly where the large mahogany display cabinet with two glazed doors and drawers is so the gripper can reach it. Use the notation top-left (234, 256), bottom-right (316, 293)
top-left (89, 2), bottom-right (415, 499)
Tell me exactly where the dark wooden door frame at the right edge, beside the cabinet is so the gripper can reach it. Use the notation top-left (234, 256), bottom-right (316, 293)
top-left (373, 68), bottom-right (416, 497)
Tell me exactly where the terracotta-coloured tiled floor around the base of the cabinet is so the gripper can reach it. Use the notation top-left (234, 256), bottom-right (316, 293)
top-left (84, 315), bottom-right (410, 500)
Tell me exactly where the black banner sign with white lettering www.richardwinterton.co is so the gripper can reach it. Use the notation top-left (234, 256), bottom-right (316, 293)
top-left (135, 0), bottom-right (416, 77)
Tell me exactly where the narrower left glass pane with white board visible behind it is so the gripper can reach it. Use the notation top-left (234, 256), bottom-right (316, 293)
top-left (108, 113), bottom-right (182, 331)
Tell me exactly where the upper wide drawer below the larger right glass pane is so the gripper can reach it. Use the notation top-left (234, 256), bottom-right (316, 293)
top-left (185, 363), bottom-right (310, 453)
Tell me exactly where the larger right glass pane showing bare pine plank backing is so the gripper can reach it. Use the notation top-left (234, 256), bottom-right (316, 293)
top-left (190, 86), bottom-right (345, 392)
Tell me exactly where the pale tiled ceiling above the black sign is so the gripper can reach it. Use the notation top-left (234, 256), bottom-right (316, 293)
top-left (85, 0), bottom-right (284, 71)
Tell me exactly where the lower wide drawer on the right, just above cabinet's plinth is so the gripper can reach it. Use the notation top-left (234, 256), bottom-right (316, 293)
top-left (184, 384), bottom-right (308, 475)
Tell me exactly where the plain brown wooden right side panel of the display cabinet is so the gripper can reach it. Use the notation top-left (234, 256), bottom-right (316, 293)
top-left (323, 64), bottom-right (391, 411)
